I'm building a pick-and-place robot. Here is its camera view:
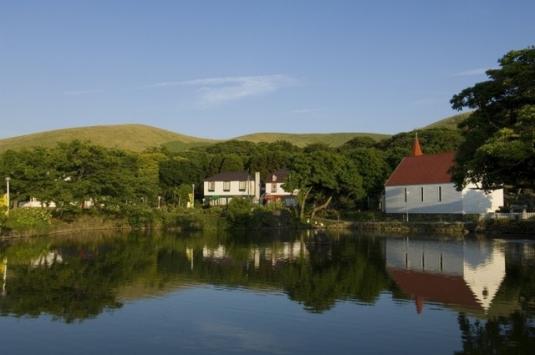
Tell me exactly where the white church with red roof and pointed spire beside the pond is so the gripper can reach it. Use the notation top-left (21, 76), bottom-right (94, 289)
top-left (384, 137), bottom-right (503, 214)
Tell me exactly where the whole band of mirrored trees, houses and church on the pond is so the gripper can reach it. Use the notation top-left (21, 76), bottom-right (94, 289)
top-left (0, 234), bottom-right (535, 353)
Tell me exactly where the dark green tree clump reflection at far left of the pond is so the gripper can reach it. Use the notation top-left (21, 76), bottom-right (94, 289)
top-left (0, 238), bottom-right (156, 322)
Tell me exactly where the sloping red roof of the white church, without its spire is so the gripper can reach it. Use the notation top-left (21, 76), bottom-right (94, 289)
top-left (385, 152), bottom-right (455, 186)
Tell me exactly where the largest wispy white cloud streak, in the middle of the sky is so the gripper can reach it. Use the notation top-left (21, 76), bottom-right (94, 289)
top-left (146, 74), bottom-right (297, 107)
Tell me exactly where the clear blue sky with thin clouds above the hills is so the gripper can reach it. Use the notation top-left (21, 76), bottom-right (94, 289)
top-left (0, 0), bottom-right (535, 138)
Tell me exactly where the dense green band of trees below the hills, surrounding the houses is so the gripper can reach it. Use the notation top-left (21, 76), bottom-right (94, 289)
top-left (0, 124), bottom-right (461, 223)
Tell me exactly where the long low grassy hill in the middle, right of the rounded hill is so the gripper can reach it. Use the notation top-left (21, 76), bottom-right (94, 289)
top-left (235, 132), bottom-right (390, 147)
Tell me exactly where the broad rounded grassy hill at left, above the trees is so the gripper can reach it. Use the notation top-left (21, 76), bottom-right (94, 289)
top-left (0, 124), bottom-right (215, 152)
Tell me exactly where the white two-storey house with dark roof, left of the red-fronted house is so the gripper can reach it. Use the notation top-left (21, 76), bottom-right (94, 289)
top-left (204, 171), bottom-right (260, 206)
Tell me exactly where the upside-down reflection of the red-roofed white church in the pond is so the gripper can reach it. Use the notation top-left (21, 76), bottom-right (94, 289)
top-left (385, 238), bottom-right (505, 313)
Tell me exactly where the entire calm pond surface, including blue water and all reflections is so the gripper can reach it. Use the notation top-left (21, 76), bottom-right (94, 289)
top-left (0, 229), bottom-right (535, 354)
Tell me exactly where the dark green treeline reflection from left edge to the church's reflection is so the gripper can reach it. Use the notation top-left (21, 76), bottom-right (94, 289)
top-left (0, 235), bottom-right (394, 322)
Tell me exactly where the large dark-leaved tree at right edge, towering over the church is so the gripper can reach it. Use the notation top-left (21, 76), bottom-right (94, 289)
top-left (451, 47), bottom-right (535, 190)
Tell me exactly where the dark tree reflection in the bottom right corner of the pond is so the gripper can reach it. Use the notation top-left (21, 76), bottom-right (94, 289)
top-left (457, 312), bottom-right (535, 355)
